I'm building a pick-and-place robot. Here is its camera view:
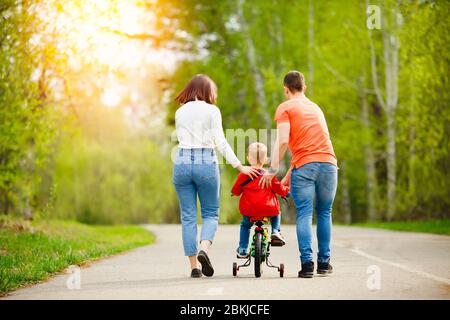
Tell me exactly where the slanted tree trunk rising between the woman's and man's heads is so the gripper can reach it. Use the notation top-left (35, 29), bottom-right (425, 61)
top-left (237, 0), bottom-right (272, 128)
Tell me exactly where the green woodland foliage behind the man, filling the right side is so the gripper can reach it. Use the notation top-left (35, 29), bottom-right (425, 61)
top-left (161, 0), bottom-right (450, 221)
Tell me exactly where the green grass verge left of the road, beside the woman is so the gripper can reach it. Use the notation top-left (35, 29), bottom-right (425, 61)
top-left (0, 218), bottom-right (154, 295)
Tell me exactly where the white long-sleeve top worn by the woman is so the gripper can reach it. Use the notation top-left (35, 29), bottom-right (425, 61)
top-left (175, 100), bottom-right (241, 168)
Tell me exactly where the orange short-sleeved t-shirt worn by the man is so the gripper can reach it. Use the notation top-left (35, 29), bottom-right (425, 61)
top-left (275, 96), bottom-right (337, 168)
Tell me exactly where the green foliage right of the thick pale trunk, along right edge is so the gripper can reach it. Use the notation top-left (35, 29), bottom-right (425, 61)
top-left (398, 1), bottom-right (450, 218)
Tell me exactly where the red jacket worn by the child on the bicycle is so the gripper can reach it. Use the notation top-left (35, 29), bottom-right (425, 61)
top-left (231, 170), bottom-right (289, 217)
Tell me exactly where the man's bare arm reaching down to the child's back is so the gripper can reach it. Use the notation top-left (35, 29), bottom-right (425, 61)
top-left (259, 121), bottom-right (291, 187)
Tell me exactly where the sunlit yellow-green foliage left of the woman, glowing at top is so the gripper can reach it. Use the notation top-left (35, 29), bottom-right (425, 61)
top-left (0, 1), bottom-right (177, 224)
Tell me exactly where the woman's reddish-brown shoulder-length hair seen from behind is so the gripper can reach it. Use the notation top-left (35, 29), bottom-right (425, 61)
top-left (175, 74), bottom-right (217, 104)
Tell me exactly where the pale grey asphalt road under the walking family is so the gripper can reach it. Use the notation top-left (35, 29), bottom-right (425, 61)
top-left (5, 225), bottom-right (450, 300)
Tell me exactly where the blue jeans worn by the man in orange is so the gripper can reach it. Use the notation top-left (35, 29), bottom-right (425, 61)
top-left (291, 162), bottom-right (337, 264)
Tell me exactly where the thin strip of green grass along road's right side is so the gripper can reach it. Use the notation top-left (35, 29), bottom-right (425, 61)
top-left (353, 219), bottom-right (450, 235)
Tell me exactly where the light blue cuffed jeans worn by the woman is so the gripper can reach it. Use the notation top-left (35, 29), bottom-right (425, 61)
top-left (173, 148), bottom-right (220, 256)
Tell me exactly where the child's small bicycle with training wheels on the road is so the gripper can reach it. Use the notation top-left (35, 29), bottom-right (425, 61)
top-left (233, 217), bottom-right (284, 278)
